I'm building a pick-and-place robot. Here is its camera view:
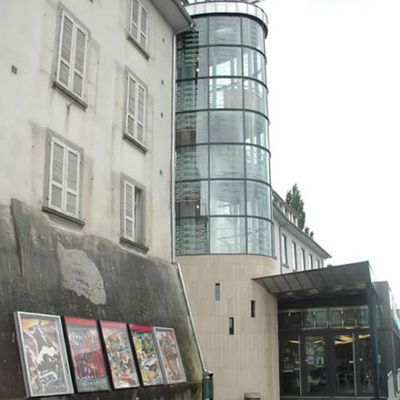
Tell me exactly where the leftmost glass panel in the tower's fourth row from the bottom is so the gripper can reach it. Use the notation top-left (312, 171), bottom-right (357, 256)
top-left (176, 111), bottom-right (208, 146)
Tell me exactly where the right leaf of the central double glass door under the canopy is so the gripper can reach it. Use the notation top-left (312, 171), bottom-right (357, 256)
top-left (333, 334), bottom-right (355, 396)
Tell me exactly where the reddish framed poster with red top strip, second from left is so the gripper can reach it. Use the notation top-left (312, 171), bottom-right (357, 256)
top-left (64, 317), bottom-right (110, 393)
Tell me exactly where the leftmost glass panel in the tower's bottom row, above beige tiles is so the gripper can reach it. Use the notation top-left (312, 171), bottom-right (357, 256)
top-left (176, 217), bottom-right (210, 254)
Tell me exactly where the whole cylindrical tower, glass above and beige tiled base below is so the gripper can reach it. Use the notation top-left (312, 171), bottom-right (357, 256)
top-left (175, 1), bottom-right (279, 400)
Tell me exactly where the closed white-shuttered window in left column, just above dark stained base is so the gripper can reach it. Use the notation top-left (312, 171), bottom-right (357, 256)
top-left (48, 137), bottom-right (82, 217)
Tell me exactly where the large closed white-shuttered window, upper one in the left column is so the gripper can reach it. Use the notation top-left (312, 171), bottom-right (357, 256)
top-left (56, 10), bottom-right (89, 99)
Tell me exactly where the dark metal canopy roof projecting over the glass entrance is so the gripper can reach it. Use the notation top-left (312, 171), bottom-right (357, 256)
top-left (254, 261), bottom-right (371, 300)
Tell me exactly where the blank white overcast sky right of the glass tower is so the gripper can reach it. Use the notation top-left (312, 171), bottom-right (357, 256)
top-left (259, 0), bottom-right (400, 303)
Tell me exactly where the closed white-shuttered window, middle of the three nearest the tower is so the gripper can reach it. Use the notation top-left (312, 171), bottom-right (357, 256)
top-left (125, 74), bottom-right (147, 144)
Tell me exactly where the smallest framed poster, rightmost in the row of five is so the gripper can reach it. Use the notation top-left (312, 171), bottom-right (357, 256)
top-left (154, 327), bottom-right (186, 383)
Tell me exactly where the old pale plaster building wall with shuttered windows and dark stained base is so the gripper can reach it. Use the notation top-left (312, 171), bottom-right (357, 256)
top-left (0, 0), bottom-right (201, 399)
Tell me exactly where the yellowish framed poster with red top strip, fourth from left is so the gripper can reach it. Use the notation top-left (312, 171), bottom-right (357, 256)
top-left (129, 324), bottom-right (164, 386)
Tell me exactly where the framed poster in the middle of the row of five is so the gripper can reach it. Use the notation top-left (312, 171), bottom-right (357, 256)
top-left (100, 321), bottom-right (140, 389)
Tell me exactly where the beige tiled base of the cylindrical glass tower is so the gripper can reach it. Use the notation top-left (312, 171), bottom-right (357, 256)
top-left (178, 255), bottom-right (279, 400)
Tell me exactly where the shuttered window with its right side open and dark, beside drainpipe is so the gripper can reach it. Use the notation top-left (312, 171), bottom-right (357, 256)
top-left (123, 179), bottom-right (143, 243)
